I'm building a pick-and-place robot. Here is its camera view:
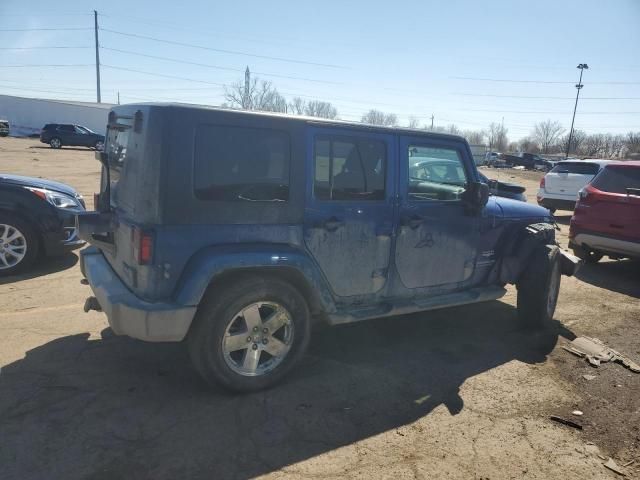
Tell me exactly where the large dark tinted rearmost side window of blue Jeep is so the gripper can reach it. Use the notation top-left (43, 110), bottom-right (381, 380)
top-left (193, 125), bottom-right (291, 202)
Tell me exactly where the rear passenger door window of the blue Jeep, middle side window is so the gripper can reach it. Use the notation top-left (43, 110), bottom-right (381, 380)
top-left (313, 136), bottom-right (387, 200)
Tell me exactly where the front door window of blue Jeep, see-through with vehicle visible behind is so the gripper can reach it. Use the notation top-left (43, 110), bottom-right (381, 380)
top-left (407, 145), bottom-right (467, 200)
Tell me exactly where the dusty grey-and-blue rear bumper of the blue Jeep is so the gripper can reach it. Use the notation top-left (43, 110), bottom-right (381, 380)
top-left (80, 248), bottom-right (196, 342)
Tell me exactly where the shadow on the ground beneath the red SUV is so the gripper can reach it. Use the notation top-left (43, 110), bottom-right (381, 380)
top-left (576, 260), bottom-right (640, 298)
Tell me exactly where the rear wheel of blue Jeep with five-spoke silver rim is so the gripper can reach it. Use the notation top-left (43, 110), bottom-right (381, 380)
top-left (187, 275), bottom-right (311, 392)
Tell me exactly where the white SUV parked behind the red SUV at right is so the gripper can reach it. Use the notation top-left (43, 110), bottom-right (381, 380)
top-left (536, 159), bottom-right (611, 213)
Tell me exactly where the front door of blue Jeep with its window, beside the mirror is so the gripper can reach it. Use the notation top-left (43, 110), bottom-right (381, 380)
top-left (395, 137), bottom-right (479, 292)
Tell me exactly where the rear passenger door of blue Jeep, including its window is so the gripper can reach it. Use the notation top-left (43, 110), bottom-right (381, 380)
top-left (304, 128), bottom-right (396, 297)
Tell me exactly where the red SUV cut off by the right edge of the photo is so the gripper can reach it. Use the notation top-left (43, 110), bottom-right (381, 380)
top-left (569, 161), bottom-right (640, 263)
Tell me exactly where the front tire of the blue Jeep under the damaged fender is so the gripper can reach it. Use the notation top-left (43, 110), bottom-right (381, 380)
top-left (516, 245), bottom-right (561, 328)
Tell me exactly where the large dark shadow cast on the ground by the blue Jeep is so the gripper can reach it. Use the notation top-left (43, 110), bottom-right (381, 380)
top-left (0, 302), bottom-right (574, 480)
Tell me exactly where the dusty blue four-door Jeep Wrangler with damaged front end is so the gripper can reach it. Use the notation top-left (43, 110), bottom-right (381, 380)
top-left (77, 104), bottom-right (577, 391)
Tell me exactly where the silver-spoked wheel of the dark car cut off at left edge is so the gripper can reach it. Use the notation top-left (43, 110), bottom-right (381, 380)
top-left (0, 213), bottom-right (40, 276)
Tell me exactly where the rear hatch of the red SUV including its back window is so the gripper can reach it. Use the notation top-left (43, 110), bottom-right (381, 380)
top-left (588, 165), bottom-right (640, 242)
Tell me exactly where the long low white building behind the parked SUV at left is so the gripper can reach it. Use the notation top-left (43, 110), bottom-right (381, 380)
top-left (0, 95), bottom-right (113, 137)
